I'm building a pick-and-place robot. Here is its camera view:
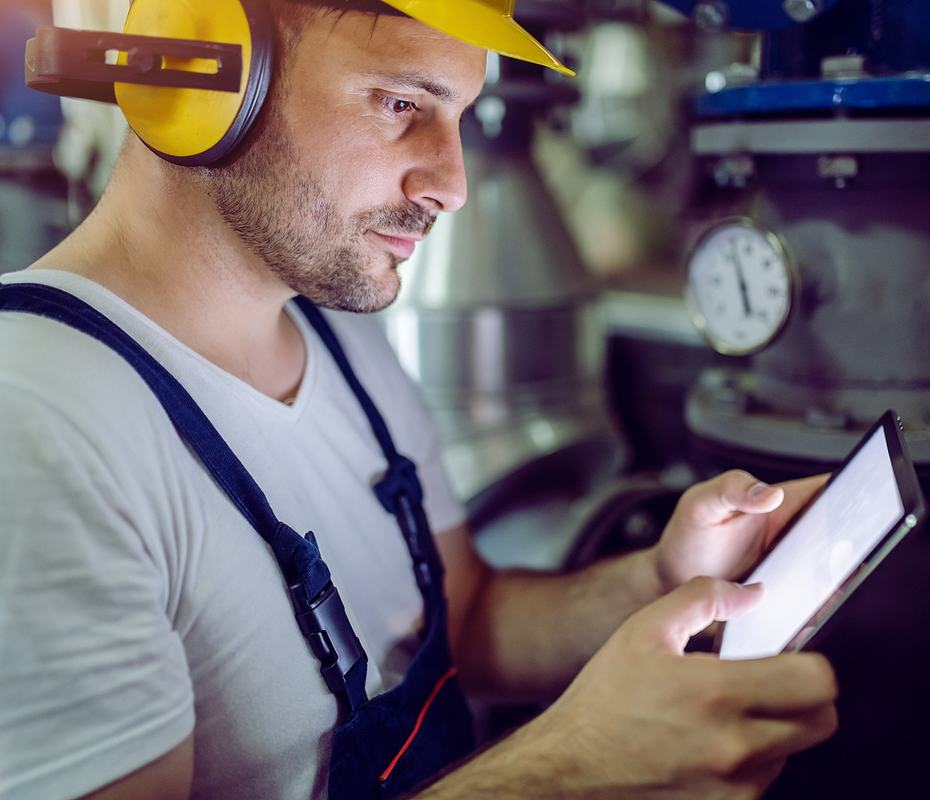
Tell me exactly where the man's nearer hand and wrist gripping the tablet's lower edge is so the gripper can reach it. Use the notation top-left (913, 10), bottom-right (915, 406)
top-left (516, 578), bottom-right (837, 798)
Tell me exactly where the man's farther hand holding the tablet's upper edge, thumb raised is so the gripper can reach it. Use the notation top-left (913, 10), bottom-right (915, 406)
top-left (653, 470), bottom-right (828, 590)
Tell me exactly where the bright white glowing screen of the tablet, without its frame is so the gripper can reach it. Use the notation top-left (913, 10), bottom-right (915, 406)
top-left (720, 427), bottom-right (904, 658)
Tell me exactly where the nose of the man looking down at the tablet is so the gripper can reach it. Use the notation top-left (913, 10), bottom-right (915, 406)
top-left (403, 123), bottom-right (468, 211)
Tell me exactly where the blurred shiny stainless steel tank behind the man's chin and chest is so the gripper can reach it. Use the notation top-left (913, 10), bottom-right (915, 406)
top-left (383, 143), bottom-right (619, 506)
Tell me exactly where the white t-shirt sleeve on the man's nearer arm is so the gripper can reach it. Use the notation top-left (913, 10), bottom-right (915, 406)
top-left (0, 384), bottom-right (194, 800)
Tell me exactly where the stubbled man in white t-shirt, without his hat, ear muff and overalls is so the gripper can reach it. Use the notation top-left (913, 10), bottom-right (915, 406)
top-left (0, 0), bottom-right (836, 798)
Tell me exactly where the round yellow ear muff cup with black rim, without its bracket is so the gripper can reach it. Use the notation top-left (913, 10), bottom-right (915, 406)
top-left (115, 0), bottom-right (274, 166)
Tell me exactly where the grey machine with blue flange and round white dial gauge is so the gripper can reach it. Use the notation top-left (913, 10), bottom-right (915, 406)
top-left (669, 0), bottom-right (930, 474)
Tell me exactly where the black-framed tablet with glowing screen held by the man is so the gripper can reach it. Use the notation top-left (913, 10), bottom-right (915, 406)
top-left (717, 411), bottom-right (926, 659)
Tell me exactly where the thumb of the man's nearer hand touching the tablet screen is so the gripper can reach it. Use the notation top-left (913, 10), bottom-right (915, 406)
top-left (624, 578), bottom-right (762, 654)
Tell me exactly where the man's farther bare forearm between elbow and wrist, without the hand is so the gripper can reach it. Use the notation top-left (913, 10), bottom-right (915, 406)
top-left (458, 550), bottom-right (661, 698)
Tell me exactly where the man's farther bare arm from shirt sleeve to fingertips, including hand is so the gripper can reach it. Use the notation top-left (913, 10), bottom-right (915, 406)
top-left (438, 472), bottom-right (825, 698)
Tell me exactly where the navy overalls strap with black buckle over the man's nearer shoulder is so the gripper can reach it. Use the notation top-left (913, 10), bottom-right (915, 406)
top-left (0, 284), bottom-right (370, 710)
